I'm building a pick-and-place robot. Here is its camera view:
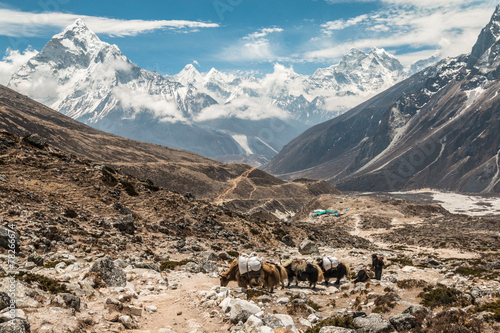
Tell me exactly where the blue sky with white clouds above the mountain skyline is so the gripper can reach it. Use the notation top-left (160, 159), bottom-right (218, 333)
top-left (0, 0), bottom-right (498, 78)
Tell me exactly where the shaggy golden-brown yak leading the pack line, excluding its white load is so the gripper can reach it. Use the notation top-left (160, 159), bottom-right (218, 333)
top-left (220, 259), bottom-right (280, 293)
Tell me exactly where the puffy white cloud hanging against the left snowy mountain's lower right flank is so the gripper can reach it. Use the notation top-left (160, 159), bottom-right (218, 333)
top-left (113, 86), bottom-right (186, 123)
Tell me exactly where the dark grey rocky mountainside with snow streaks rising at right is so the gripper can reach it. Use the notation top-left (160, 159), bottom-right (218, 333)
top-left (266, 6), bottom-right (500, 192)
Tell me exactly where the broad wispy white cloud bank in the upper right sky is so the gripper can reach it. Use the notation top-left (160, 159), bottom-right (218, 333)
top-left (302, 0), bottom-right (494, 61)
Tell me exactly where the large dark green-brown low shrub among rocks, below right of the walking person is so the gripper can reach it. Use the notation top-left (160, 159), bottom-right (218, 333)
top-left (418, 285), bottom-right (471, 309)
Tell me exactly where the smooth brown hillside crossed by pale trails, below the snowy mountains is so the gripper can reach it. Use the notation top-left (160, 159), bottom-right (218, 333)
top-left (0, 86), bottom-right (338, 216)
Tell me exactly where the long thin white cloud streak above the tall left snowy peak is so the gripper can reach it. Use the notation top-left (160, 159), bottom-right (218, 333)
top-left (0, 8), bottom-right (219, 37)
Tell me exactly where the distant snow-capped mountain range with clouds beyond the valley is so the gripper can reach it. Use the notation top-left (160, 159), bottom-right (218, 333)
top-left (8, 20), bottom-right (432, 165)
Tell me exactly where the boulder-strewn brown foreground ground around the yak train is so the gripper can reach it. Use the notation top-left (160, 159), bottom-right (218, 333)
top-left (0, 133), bottom-right (500, 333)
